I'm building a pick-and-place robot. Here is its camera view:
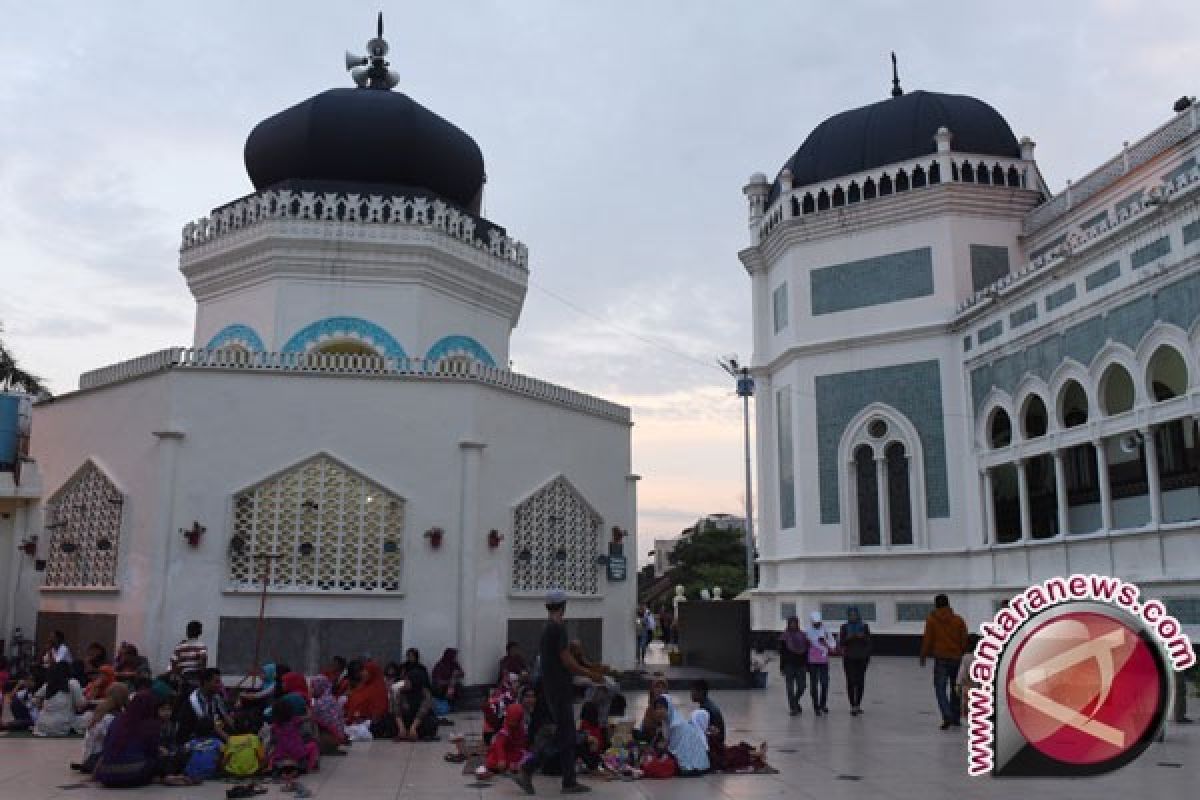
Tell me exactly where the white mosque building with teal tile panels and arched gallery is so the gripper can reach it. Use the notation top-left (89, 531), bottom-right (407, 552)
top-left (740, 73), bottom-right (1200, 636)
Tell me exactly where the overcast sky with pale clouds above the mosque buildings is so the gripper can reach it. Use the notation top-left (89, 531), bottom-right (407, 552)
top-left (0, 0), bottom-right (1200, 563)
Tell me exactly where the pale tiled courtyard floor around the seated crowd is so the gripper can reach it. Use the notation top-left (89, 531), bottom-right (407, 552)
top-left (0, 657), bottom-right (1200, 800)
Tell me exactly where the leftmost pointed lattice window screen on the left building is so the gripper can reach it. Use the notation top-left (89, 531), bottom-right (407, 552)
top-left (42, 462), bottom-right (125, 587)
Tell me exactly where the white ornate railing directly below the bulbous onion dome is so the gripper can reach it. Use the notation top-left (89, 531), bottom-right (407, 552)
top-left (180, 190), bottom-right (529, 269)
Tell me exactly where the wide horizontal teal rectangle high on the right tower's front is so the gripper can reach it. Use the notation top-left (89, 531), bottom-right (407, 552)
top-left (809, 247), bottom-right (934, 317)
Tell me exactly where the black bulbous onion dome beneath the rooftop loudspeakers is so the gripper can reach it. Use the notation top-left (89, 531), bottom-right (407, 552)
top-left (245, 89), bottom-right (484, 213)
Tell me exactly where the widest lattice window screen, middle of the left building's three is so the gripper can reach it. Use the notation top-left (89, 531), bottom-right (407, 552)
top-left (229, 456), bottom-right (404, 591)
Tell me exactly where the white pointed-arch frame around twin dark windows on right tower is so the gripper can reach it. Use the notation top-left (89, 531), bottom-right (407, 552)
top-left (838, 403), bottom-right (929, 551)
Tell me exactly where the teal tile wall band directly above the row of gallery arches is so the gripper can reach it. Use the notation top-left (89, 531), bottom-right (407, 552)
top-left (971, 272), bottom-right (1200, 414)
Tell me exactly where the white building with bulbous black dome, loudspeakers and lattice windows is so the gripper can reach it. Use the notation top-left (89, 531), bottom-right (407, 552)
top-left (21, 24), bottom-right (637, 682)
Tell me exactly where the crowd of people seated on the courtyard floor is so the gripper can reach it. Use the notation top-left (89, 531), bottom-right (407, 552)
top-left (0, 624), bottom-right (766, 796)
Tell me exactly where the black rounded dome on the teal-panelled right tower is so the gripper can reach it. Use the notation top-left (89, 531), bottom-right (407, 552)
top-left (770, 91), bottom-right (1021, 199)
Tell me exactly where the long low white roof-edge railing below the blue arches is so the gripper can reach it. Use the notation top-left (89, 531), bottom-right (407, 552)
top-left (79, 348), bottom-right (630, 423)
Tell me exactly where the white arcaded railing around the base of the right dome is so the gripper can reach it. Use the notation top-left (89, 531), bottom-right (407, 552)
top-left (751, 151), bottom-right (1040, 242)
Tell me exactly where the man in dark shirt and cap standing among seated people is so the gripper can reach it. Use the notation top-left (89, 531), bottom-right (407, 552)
top-left (516, 589), bottom-right (604, 794)
